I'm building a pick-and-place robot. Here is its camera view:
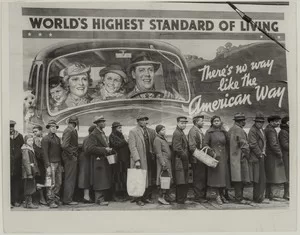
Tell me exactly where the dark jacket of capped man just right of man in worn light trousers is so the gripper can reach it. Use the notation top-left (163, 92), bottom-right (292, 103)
top-left (61, 126), bottom-right (78, 161)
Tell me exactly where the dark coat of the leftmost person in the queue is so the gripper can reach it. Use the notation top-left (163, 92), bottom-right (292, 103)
top-left (10, 131), bottom-right (24, 179)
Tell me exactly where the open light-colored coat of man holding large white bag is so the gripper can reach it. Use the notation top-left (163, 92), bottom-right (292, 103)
top-left (128, 125), bottom-right (156, 187)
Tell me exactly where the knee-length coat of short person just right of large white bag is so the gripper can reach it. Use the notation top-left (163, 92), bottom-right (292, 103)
top-left (153, 135), bottom-right (172, 185)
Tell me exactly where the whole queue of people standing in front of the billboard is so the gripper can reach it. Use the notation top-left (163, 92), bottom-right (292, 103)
top-left (10, 113), bottom-right (289, 208)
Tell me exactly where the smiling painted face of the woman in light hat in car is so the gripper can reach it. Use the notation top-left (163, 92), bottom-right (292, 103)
top-left (69, 73), bottom-right (89, 97)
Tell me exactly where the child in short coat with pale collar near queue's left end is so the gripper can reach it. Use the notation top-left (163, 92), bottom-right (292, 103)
top-left (21, 134), bottom-right (39, 209)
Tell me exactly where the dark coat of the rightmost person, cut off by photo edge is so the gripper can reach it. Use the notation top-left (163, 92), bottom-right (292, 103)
top-left (278, 124), bottom-right (290, 181)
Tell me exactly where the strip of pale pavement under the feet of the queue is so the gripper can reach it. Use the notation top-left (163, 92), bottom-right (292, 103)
top-left (12, 187), bottom-right (289, 211)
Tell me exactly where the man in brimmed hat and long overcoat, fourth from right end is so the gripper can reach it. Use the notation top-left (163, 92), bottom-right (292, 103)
top-left (228, 113), bottom-right (251, 204)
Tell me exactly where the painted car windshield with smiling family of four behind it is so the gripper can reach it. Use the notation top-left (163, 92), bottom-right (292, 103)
top-left (47, 48), bottom-right (189, 113)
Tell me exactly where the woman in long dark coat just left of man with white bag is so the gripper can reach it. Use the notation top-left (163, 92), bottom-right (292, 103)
top-left (109, 122), bottom-right (130, 199)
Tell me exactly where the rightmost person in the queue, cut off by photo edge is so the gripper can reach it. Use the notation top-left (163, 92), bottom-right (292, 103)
top-left (278, 116), bottom-right (290, 200)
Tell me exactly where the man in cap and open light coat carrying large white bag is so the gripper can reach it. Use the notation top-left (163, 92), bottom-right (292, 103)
top-left (128, 113), bottom-right (156, 206)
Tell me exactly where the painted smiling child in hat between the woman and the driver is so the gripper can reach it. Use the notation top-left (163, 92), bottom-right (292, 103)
top-left (92, 65), bottom-right (127, 103)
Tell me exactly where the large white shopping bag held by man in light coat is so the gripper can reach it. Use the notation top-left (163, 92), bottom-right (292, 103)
top-left (127, 168), bottom-right (147, 197)
